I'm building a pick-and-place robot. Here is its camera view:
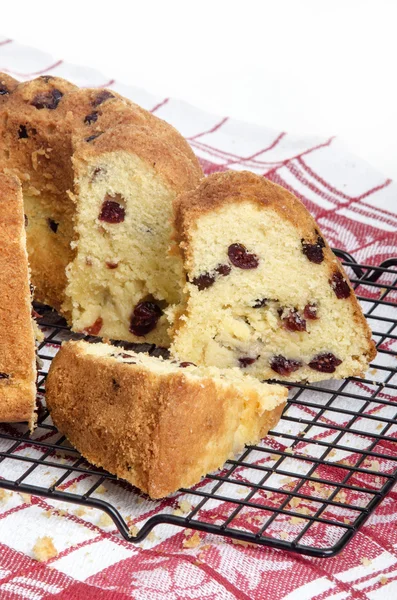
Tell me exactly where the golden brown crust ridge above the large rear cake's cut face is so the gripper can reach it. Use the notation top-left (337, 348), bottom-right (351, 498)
top-left (74, 125), bottom-right (203, 193)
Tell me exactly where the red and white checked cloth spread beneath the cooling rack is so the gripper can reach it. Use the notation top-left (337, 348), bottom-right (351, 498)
top-left (0, 36), bottom-right (397, 600)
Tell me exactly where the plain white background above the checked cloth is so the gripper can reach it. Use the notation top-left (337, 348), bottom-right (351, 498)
top-left (0, 0), bottom-right (397, 182)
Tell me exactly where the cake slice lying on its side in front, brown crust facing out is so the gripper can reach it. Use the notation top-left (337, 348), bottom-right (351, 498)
top-left (46, 341), bottom-right (287, 498)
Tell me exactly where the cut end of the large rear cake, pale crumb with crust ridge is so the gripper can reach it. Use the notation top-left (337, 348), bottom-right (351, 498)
top-left (63, 125), bottom-right (201, 346)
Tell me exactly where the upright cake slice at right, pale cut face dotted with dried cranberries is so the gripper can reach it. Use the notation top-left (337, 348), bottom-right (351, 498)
top-left (170, 171), bottom-right (376, 381)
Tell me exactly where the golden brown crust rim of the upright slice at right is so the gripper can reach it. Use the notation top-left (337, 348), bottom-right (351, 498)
top-left (174, 171), bottom-right (376, 361)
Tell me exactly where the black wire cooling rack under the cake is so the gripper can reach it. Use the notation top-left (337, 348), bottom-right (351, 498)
top-left (0, 250), bottom-right (397, 557)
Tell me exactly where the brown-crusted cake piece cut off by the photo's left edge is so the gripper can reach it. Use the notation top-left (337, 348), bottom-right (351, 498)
top-left (0, 174), bottom-right (36, 429)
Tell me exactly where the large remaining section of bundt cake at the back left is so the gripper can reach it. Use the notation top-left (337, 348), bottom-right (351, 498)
top-left (0, 76), bottom-right (202, 344)
